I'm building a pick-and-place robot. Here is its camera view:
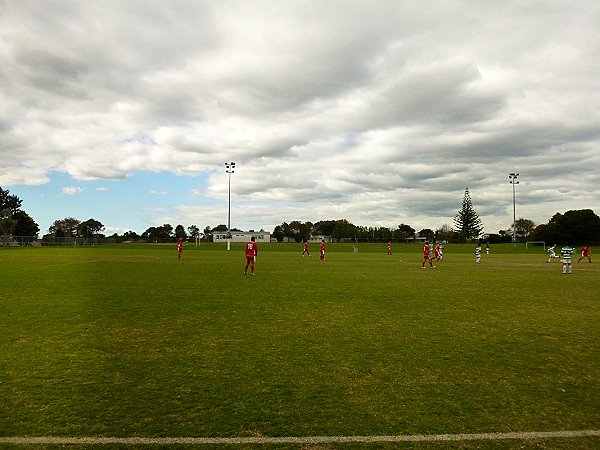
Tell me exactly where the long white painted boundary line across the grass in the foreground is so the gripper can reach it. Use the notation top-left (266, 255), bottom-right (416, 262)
top-left (0, 430), bottom-right (600, 445)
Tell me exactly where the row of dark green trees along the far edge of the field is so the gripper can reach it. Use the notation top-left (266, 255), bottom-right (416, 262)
top-left (0, 187), bottom-right (600, 245)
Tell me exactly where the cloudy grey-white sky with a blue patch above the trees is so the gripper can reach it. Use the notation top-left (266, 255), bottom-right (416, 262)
top-left (0, 0), bottom-right (600, 234)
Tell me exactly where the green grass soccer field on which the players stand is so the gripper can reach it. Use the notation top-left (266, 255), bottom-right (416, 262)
top-left (0, 244), bottom-right (600, 449)
